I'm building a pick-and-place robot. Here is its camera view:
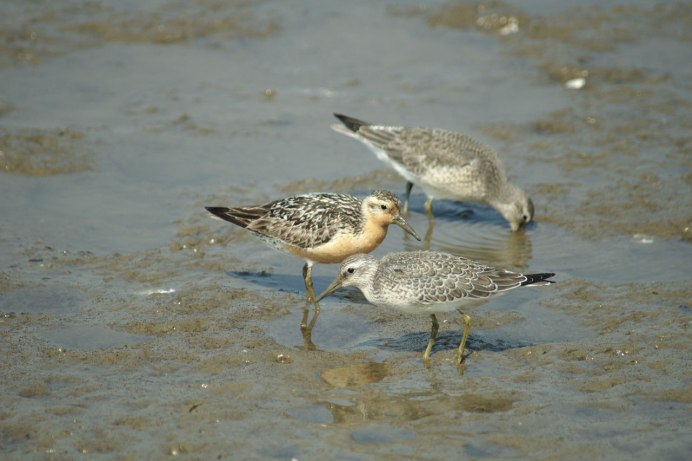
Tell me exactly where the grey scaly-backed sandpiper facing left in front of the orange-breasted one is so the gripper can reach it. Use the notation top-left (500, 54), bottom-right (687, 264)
top-left (317, 251), bottom-right (555, 363)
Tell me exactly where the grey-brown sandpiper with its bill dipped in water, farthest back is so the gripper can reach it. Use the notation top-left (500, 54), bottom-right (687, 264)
top-left (332, 114), bottom-right (534, 231)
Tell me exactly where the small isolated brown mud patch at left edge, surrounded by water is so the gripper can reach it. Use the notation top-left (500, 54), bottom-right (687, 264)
top-left (0, 129), bottom-right (92, 176)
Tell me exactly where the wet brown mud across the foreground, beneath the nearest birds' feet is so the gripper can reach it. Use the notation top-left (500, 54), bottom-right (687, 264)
top-left (0, 218), bottom-right (692, 459)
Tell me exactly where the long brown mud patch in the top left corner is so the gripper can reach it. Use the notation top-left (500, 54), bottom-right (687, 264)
top-left (0, 0), bottom-right (281, 68)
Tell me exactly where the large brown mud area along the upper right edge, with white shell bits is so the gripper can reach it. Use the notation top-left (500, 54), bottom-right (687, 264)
top-left (410, 1), bottom-right (692, 241)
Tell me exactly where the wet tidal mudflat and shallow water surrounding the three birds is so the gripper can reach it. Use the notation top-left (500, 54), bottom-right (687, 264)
top-left (0, 0), bottom-right (692, 460)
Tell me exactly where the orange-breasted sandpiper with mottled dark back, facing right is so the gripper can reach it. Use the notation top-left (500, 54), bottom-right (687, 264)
top-left (206, 190), bottom-right (420, 302)
